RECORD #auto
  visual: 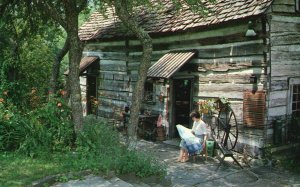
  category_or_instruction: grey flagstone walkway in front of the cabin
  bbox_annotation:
[49,140,300,187]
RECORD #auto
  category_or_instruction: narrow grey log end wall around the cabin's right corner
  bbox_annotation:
[267,0,300,143]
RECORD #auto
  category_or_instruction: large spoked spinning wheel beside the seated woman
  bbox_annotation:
[211,101,238,150]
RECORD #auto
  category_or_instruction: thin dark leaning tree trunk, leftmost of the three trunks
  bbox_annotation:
[49,38,70,93]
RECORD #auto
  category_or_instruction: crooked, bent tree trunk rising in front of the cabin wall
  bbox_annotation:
[114,0,152,149]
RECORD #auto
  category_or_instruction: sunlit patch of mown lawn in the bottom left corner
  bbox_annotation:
[0,153,79,187]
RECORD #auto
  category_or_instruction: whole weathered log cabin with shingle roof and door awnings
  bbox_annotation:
[79,0,300,157]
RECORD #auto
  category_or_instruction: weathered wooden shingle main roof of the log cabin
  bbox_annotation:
[79,0,272,41]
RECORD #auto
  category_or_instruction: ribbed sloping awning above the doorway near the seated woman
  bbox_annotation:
[147,50,197,79]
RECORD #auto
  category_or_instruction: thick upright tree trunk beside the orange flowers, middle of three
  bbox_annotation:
[64,0,83,134]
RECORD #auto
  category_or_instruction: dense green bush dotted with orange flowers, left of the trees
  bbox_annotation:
[0,93,74,156]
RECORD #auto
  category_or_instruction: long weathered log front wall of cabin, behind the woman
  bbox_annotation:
[84,18,268,155]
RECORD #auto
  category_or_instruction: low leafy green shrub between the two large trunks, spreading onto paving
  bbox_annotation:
[76,116,165,177]
